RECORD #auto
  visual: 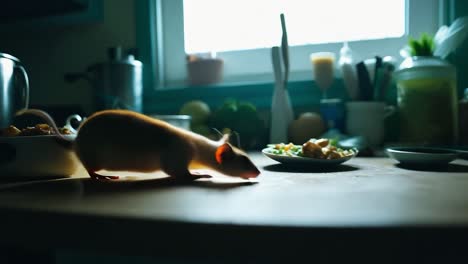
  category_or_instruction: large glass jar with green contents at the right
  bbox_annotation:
[395,57,458,146]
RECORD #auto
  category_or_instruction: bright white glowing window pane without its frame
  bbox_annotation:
[183,0,405,53]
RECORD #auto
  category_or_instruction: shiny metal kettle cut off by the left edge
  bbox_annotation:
[0,53,29,129]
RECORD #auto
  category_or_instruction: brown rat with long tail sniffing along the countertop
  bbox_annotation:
[17,109,260,181]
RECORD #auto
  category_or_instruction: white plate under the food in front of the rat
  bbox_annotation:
[262,148,357,166]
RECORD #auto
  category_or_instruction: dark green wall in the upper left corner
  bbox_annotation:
[0,0,136,112]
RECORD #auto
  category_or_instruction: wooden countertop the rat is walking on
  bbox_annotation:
[0,153,468,256]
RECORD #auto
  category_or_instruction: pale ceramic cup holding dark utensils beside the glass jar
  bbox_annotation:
[346,101,395,148]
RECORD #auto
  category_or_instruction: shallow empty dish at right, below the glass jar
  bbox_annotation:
[387,147,458,165]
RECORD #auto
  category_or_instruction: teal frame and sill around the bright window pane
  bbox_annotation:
[155,0,447,89]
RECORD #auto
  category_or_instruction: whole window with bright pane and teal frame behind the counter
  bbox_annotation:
[157,0,442,86]
